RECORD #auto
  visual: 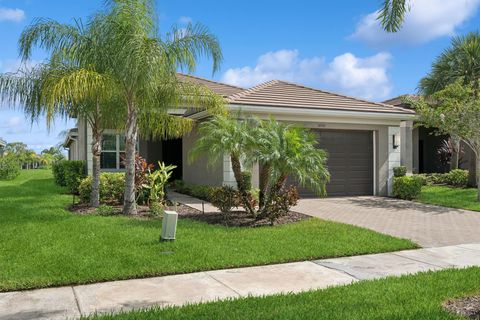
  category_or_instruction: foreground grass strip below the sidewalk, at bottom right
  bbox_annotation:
[88,268,480,320]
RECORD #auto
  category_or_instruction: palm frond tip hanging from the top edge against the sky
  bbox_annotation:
[378,0,410,32]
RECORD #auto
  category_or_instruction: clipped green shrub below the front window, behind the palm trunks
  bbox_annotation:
[79,172,125,205]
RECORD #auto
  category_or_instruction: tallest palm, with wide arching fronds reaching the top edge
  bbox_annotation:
[9,0,223,214]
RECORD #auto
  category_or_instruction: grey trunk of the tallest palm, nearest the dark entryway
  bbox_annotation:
[123,101,138,215]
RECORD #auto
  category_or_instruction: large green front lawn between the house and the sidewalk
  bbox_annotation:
[0,170,416,291]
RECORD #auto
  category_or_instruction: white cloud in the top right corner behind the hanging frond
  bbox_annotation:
[351,0,480,45]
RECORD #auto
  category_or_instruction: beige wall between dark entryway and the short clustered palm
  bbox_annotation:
[182,124,225,186]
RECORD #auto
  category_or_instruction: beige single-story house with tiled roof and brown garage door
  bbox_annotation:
[64,75,415,196]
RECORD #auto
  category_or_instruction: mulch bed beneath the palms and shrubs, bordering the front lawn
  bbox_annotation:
[69,203,310,227]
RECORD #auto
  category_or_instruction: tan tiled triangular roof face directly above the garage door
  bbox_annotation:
[227,80,414,114]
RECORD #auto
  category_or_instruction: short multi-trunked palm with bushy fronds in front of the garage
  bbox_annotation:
[190,115,330,217]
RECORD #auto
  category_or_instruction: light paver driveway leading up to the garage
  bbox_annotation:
[293,197,480,247]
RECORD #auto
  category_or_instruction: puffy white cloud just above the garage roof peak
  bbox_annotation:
[222,50,392,100]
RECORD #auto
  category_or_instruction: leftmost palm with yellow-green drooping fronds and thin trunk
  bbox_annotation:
[0,57,119,207]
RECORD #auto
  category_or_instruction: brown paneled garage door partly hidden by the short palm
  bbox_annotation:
[290,130,373,197]
